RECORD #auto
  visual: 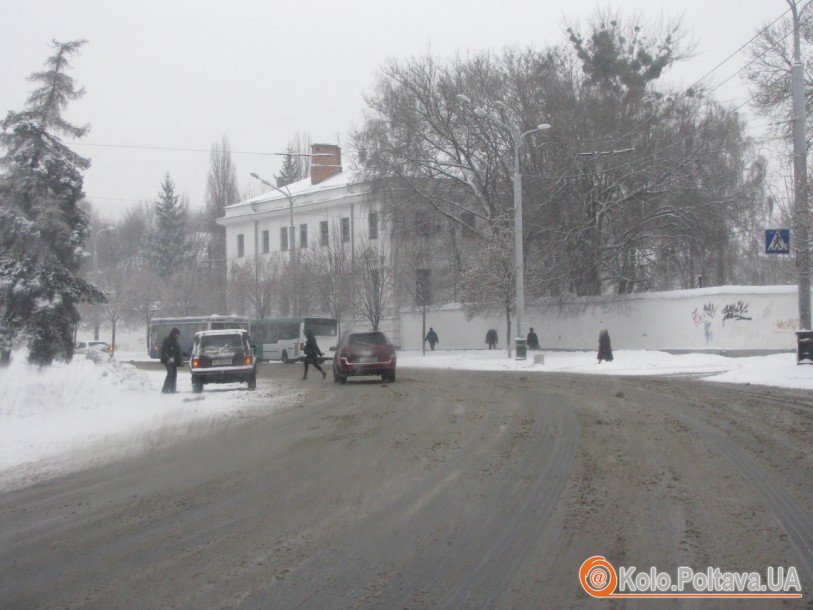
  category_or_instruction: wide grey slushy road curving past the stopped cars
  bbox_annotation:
[0,366,813,608]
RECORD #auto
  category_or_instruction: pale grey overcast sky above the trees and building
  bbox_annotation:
[0,0,788,216]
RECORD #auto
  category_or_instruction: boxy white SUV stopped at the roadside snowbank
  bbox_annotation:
[189,329,257,393]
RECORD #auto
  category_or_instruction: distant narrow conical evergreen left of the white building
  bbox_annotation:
[150,173,188,279]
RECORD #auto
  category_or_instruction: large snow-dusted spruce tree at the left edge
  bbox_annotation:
[0,40,105,365]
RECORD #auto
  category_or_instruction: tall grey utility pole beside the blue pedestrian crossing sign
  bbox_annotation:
[787,0,810,330]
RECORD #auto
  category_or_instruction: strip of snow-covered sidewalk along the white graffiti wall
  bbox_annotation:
[398,349,813,389]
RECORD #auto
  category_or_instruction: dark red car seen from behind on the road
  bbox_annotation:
[333,330,396,383]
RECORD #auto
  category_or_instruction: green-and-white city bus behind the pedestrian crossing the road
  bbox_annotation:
[251,318,339,362]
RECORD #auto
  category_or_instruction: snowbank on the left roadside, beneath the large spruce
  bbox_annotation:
[0,353,274,490]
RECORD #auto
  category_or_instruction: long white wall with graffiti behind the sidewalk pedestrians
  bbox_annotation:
[400,286,799,350]
